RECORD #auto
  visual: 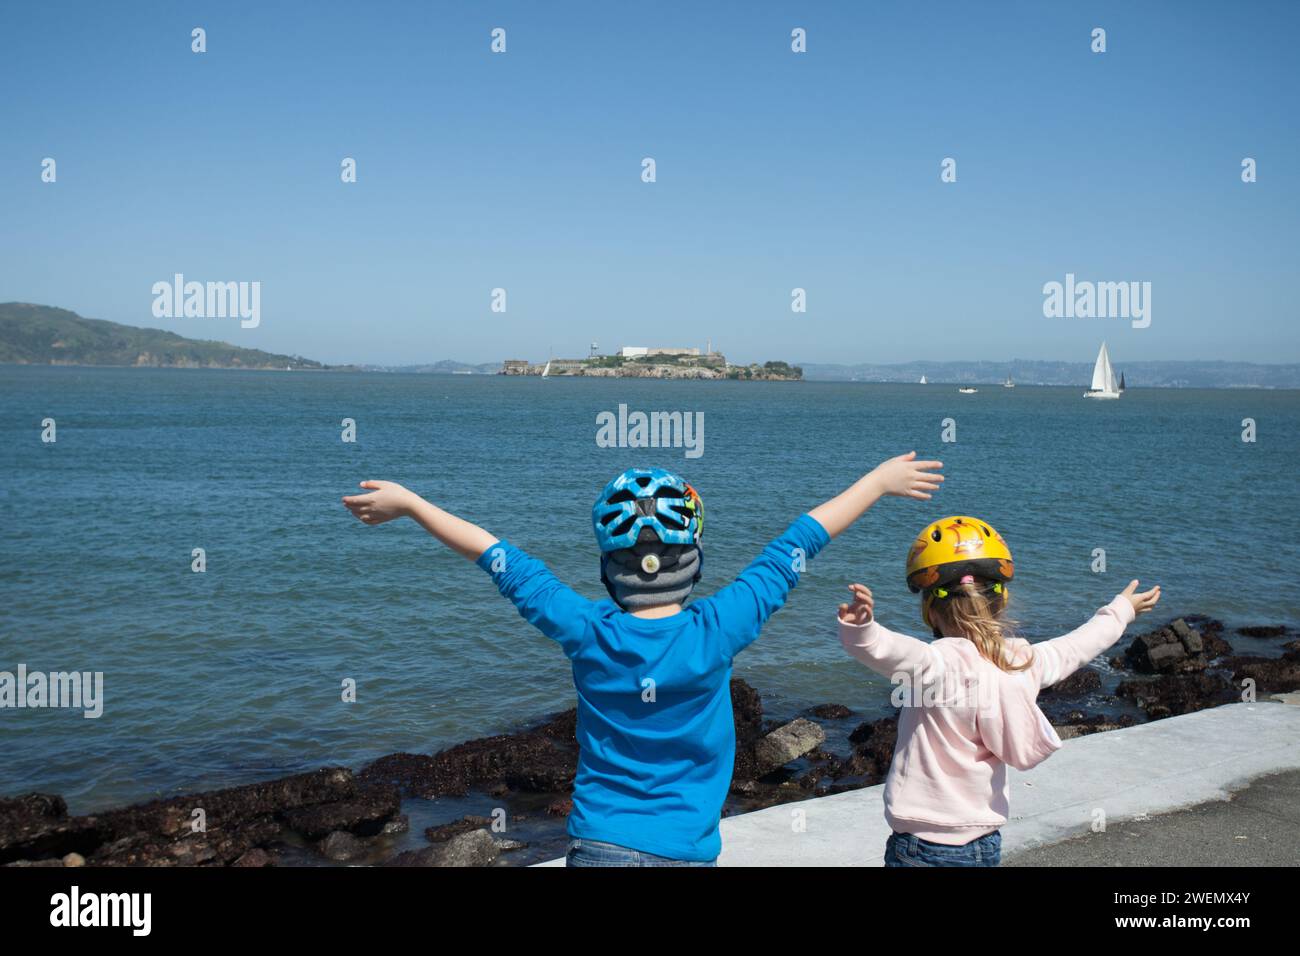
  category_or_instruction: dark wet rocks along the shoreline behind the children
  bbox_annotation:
[0,615,1300,866]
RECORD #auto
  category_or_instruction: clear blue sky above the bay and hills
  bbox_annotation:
[0,0,1300,363]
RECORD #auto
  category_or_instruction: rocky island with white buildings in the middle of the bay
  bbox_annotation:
[501,343,803,381]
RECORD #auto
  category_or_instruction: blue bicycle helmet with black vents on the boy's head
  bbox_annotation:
[592,468,705,554]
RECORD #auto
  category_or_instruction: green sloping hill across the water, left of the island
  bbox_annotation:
[0,302,329,369]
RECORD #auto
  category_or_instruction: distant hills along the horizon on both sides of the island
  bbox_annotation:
[0,302,1300,389]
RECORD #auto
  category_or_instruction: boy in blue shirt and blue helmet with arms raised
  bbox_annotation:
[343,451,944,866]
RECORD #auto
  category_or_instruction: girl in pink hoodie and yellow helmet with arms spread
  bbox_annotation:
[840,515,1160,866]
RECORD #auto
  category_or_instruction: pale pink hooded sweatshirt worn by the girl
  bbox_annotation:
[840,596,1134,845]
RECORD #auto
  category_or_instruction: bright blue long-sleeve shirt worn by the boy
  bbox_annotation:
[478,515,831,860]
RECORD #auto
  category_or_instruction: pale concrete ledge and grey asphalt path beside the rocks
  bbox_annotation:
[542,696,1300,866]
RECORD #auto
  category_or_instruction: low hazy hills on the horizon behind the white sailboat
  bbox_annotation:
[802,355,1300,389]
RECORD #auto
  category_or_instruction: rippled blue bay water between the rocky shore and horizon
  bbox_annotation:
[0,367,1300,812]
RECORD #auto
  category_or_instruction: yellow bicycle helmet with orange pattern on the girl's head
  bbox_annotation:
[907,515,1015,623]
